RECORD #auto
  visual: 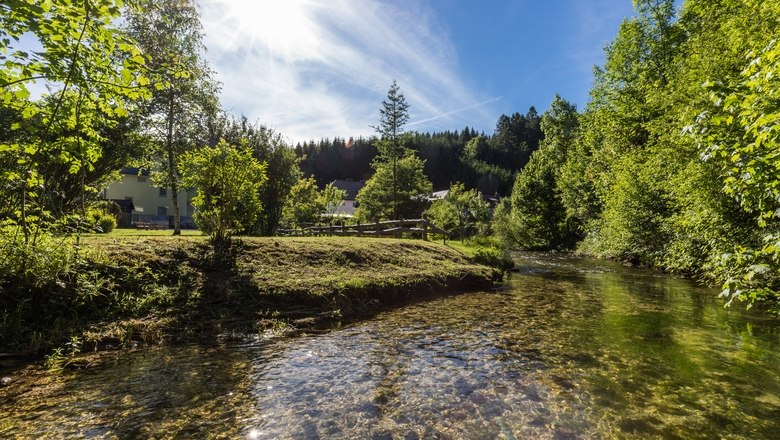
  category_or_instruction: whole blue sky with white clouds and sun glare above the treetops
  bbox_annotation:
[199,0,633,144]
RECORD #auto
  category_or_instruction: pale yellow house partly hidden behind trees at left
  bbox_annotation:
[103,168,195,228]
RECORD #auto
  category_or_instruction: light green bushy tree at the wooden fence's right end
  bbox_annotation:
[426,183,490,240]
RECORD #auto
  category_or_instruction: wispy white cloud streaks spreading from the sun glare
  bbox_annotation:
[201,0,497,142]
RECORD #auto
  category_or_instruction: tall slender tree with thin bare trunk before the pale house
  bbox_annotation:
[128,0,219,235]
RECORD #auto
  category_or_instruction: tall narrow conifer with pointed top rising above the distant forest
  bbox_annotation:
[373,80,409,219]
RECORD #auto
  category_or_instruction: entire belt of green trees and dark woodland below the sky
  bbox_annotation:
[0,0,780,310]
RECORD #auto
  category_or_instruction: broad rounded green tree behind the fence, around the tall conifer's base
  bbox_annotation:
[355,155,432,221]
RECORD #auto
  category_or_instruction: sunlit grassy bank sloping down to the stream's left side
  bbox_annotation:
[2,235,500,360]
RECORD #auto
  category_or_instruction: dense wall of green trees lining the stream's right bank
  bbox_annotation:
[498,0,780,310]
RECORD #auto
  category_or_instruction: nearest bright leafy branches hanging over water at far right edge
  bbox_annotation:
[696,41,780,310]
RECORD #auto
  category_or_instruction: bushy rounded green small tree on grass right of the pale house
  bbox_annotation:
[179,141,266,251]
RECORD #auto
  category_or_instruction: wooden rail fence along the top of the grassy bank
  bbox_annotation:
[279,219,452,242]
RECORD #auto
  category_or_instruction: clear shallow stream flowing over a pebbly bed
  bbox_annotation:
[0,254,780,439]
